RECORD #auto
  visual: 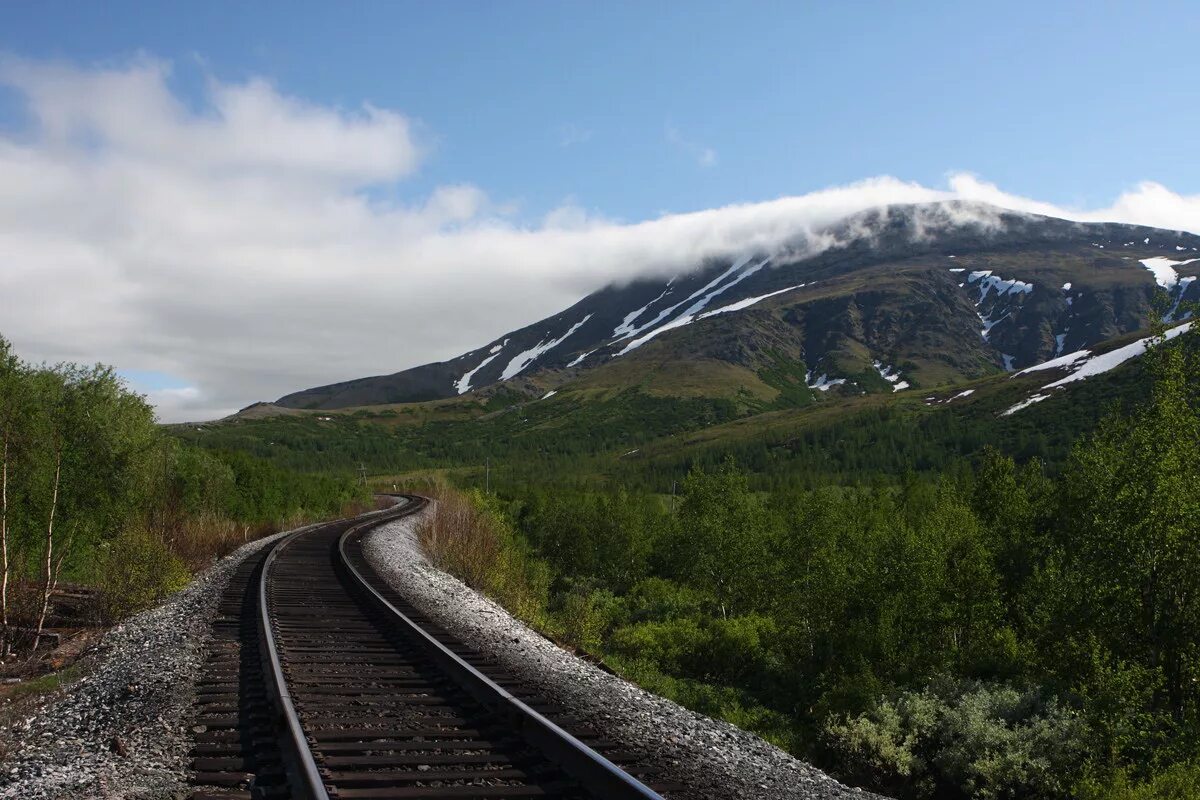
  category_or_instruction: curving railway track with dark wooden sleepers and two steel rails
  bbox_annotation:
[192,498,682,800]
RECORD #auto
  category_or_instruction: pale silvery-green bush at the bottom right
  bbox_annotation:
[824,679,1087,800]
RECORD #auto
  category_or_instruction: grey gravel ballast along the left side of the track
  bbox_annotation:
[0,525,304,799]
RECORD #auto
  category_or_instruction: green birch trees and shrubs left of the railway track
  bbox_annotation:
[0,337,368,666]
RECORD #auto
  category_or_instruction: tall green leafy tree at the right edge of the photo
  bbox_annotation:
[1048,319,1200,753]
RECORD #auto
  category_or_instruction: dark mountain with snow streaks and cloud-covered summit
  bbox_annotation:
[277,201,1200,410]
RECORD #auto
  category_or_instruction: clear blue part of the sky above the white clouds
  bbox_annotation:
[9,2,1200,221]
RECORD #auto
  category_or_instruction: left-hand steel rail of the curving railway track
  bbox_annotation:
[258,499,415,800]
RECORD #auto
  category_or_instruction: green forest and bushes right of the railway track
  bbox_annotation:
[421,321,1200,800]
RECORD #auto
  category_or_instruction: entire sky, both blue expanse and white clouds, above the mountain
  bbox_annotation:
[0,0,1200,421]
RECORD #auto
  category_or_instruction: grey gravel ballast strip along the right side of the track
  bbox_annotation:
[362,511,878,800]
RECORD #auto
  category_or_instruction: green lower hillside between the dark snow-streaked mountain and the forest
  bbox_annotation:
[173,316,1187,492]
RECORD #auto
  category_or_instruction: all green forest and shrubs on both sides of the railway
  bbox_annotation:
[7,316,1200,800]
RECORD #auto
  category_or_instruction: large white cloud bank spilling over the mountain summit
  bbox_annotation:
[0,59,1200,421]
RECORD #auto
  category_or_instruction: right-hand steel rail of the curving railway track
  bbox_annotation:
[337,495,662,800]
